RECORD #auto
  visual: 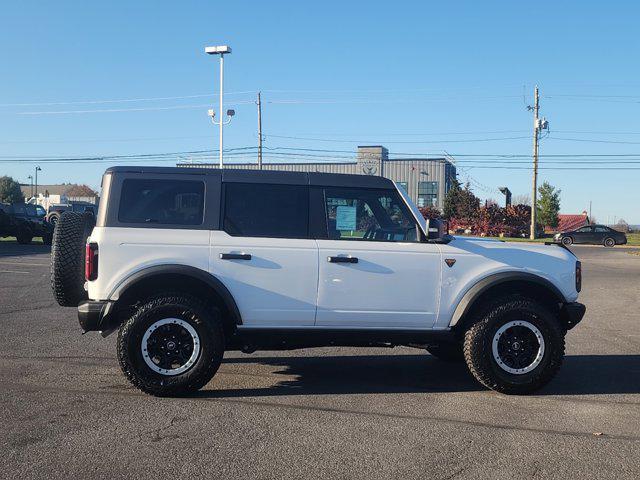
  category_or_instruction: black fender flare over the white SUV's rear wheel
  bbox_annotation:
[109,264,242,330]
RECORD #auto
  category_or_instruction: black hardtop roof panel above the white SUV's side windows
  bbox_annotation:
[105,166,395,189]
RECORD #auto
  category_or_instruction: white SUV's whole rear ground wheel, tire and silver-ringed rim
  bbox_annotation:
[118,294,224,397]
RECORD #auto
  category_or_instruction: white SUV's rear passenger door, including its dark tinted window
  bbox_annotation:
[210,182,318,327]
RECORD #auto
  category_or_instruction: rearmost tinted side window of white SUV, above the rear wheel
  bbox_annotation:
[118,179,204,225]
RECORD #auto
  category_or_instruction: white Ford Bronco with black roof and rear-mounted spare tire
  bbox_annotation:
[51,167,585,396]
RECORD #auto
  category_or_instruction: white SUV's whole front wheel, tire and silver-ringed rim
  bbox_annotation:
[464,296,564,394]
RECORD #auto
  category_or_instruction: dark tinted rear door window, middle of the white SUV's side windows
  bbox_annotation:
[223,183,309,238]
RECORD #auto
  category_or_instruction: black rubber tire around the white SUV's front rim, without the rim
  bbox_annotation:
[464,295,565,395]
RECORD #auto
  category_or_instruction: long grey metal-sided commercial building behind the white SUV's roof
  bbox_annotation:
[178,145,456,210]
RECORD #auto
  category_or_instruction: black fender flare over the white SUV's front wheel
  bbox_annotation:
[449,272,567,330]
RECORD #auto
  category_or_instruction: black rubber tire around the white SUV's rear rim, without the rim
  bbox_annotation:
[117,293,225,397]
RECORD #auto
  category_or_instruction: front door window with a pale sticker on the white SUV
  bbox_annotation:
[325,188,418,242]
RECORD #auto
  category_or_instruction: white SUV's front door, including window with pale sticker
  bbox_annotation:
[316,187,441,329]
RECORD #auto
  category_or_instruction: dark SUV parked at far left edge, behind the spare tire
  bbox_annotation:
[0,203,53,245]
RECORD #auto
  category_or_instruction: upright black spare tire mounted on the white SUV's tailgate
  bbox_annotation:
[51,212,95,307]
